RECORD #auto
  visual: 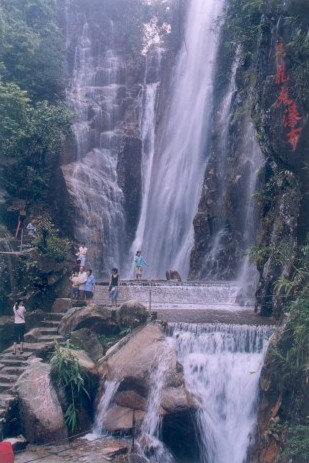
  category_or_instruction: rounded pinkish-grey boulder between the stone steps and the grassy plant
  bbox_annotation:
[16,359,68,444]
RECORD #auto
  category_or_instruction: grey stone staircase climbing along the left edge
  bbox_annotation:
[0,313,64,437]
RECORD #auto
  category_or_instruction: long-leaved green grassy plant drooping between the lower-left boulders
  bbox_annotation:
[50,342,90,432]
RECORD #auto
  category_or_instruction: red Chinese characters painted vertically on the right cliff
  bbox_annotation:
[275,42,302,151]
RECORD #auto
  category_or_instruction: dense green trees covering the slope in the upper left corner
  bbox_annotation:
[0,0,71,201]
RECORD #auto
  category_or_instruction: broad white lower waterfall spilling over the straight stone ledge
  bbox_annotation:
[169,324,273,463]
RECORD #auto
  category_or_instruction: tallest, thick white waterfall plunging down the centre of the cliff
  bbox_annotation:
[132,0,223,278]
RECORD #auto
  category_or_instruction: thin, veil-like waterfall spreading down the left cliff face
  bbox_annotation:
[62,10,126,276]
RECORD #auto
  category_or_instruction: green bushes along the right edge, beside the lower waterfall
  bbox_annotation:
[272,239,309,461]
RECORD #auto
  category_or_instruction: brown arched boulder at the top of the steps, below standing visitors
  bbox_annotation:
[58,306,119,336]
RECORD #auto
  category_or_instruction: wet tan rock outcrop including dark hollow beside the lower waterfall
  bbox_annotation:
[95,324,198,461]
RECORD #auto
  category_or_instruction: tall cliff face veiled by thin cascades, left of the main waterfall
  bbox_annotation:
[58,0,178,277]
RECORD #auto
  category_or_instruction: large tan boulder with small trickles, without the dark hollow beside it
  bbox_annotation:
[98,324,198,433]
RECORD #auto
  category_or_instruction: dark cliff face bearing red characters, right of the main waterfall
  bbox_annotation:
[191,0,309,308]
